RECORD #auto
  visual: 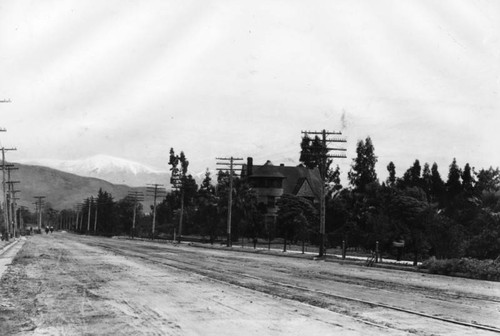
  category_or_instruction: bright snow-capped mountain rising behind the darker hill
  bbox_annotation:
[18,155,170,187]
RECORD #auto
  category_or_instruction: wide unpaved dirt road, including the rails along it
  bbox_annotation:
[0,233,500,335]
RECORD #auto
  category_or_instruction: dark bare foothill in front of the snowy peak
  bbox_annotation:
[11,163,153,210]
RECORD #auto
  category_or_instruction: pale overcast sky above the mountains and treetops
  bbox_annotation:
[0,0,500,181]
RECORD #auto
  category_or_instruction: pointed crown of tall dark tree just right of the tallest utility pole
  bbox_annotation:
[348,137,378,192]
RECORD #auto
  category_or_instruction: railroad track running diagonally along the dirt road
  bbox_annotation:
[86,241,500,334]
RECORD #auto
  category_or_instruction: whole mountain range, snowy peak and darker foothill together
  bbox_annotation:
[11,155,217,210]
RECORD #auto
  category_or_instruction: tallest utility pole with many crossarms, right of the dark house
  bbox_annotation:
[302,130,347,257]
